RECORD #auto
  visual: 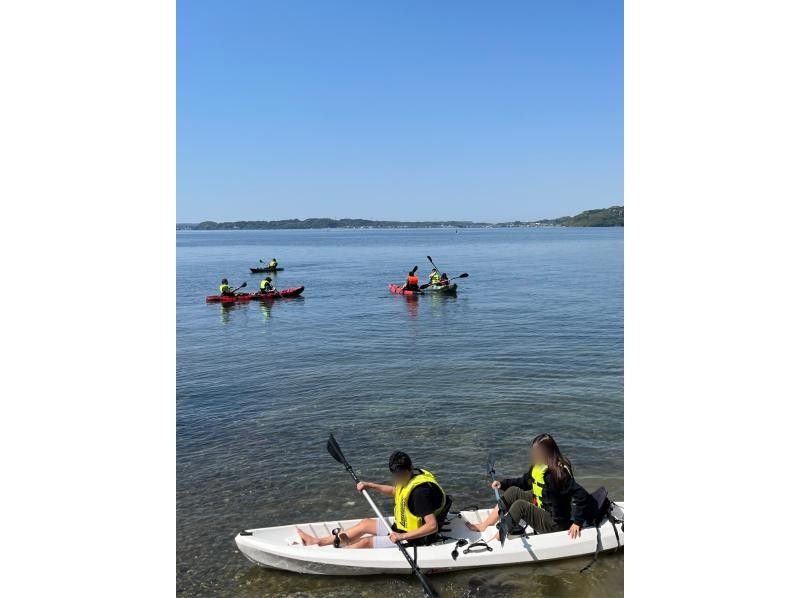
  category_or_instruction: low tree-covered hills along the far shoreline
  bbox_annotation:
[177,206,625,230]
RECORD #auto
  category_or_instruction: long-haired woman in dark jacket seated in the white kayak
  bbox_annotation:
[467,434,590,539]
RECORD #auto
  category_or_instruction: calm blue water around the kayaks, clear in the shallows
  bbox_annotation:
[176,228,624,598]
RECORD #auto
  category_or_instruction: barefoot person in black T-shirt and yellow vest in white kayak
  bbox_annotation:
[297,451,451,548]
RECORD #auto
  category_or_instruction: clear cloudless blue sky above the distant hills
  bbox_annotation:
[178,0,623,222]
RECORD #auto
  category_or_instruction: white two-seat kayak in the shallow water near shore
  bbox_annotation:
[236,503,625,575]
